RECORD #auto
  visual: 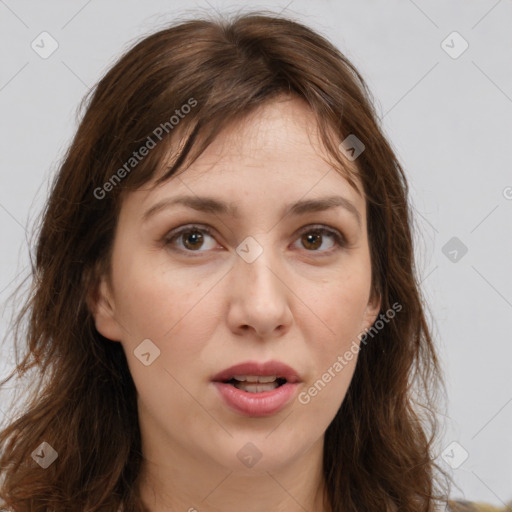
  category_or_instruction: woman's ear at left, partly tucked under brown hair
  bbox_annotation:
[87,275,122,341]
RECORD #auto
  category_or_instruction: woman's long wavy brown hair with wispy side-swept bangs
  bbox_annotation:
[0,12,444,512]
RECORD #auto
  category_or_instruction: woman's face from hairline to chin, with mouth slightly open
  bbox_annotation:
[94,99,380,480]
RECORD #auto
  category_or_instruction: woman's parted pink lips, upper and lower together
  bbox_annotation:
[212,361,301,416]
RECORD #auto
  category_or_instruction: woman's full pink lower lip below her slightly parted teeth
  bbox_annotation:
[214,382,299,417]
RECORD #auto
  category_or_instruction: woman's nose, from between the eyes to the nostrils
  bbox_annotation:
[228,240,293,339]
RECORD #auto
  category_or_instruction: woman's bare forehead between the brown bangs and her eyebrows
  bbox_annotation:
[125,97,364,219]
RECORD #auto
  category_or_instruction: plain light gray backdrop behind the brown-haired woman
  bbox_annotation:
[0,0,512,505]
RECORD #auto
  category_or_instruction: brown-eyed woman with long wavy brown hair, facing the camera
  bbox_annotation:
[0,8,504,512]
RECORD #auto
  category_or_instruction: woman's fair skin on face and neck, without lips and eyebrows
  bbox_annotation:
[93,98,380,512]
